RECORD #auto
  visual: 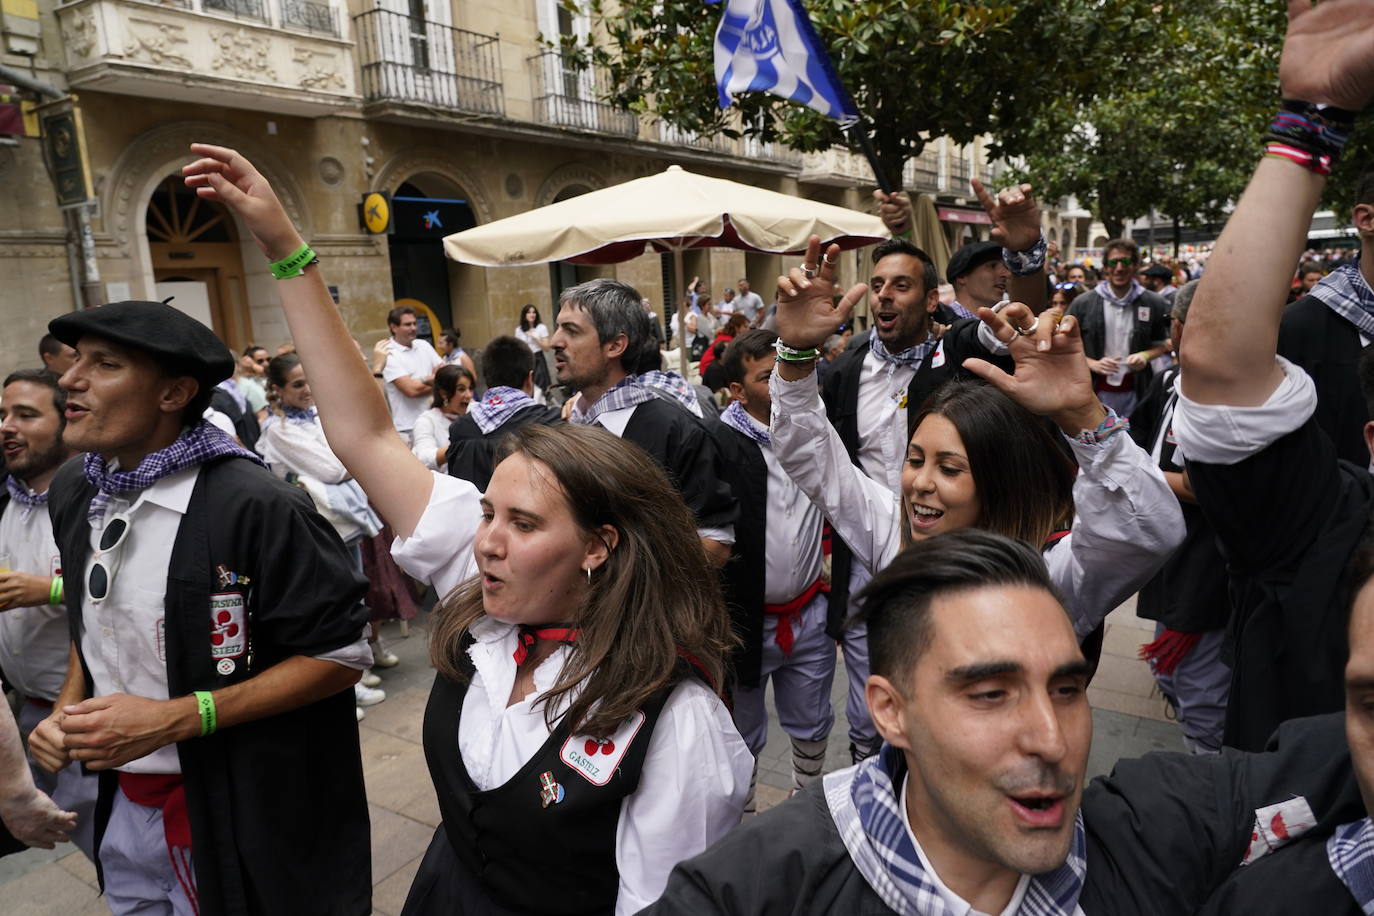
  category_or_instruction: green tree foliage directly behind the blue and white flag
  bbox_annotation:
[563,0,1151,190]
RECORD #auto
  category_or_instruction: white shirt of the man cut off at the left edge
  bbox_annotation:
[0,500,71,700]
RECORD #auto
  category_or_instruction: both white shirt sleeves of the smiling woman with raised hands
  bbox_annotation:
[768,369,1183,639]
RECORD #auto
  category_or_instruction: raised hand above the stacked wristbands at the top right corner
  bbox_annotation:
[1279,0,1374,111]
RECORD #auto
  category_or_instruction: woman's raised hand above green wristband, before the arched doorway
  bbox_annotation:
[181,143,301,261]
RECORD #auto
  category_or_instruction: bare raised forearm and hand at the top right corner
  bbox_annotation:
[1179,0,1374,407]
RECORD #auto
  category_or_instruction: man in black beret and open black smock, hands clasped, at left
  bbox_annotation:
[30,302,371,916]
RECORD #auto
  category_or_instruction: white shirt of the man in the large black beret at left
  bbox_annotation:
[80,464,372,773]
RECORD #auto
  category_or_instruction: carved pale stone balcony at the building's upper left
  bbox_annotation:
[56,0,357,117]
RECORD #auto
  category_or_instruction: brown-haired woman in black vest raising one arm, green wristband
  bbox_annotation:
[184,144,753,916]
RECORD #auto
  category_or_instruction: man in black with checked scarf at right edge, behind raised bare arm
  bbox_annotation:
[1269,172,1374,464]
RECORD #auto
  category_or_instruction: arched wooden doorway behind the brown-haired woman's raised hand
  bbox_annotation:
[146,174,253,353]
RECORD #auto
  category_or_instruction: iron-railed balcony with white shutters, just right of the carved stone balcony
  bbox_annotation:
[353,10,506,115]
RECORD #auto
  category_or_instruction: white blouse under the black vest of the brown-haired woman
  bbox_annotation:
[392,474,754,916]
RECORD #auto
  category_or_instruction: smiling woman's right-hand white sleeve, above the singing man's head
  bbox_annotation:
[1044,433,1184,639]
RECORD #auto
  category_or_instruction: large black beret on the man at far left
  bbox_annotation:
[48,299,234,386]
